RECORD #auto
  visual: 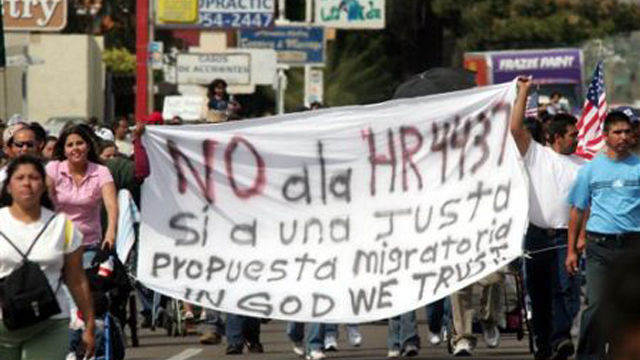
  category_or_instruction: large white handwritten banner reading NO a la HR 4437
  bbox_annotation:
[137,83,528,323]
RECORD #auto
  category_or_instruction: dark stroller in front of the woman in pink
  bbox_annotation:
[67,251,133,360]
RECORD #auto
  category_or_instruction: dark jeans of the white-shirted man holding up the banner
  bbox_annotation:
[525,225,580,355]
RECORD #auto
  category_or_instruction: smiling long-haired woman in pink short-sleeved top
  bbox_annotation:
[47,125,118,253]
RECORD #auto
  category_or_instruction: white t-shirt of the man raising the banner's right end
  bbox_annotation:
[524,140,585,229]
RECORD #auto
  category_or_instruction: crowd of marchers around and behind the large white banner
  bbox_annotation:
[0,78,640,360]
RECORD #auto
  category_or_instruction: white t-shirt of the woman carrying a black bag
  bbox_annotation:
[0,207,82,319]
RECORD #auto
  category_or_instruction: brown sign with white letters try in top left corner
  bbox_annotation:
[2,0,68,31]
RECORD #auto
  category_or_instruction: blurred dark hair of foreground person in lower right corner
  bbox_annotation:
[596,249,640,352]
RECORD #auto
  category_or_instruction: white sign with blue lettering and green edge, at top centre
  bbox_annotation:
[315,0,385,29]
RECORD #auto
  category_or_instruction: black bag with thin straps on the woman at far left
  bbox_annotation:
[0,215,60,330]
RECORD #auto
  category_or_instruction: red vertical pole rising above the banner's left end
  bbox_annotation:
[135,0,149,121]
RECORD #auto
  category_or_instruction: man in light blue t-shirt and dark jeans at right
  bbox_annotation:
[566,111,640,360]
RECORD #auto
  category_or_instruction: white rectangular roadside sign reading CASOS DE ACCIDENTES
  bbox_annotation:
[177,53,251,85]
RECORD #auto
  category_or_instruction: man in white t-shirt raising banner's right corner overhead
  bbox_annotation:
[511,78,584,360]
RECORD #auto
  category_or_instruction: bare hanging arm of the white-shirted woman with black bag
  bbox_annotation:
[63,247,95,357]
